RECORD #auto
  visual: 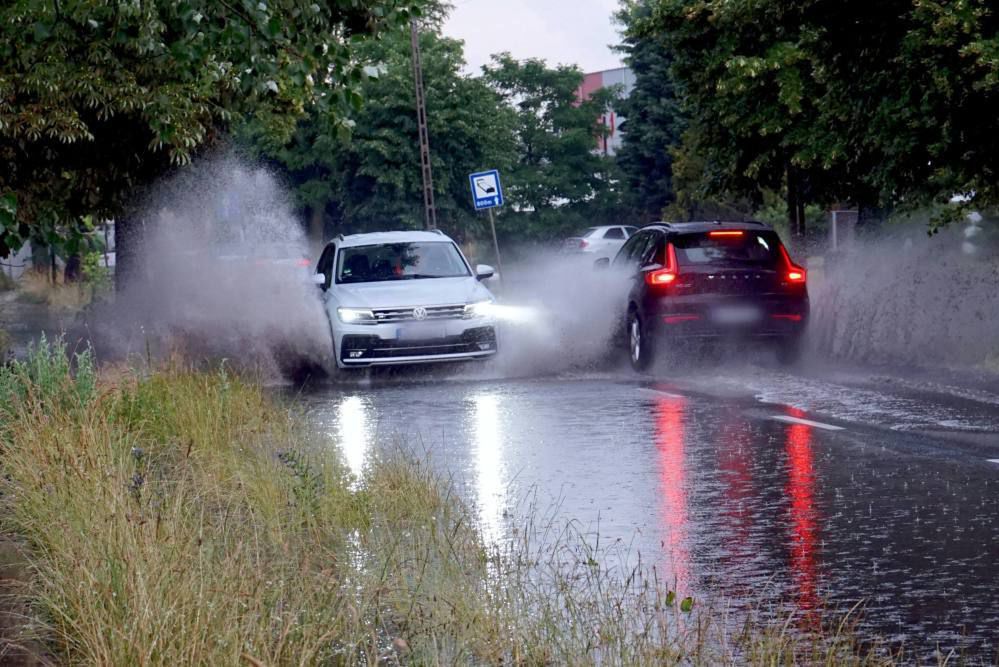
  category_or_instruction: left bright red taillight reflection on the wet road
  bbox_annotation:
[656,396,690,595]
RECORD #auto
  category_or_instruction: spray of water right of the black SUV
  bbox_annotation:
[811,227,999,367]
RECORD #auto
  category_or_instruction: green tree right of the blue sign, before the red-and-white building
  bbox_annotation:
[483,54,619,239]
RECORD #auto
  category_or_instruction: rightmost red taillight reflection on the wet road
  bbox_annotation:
[784,409,819,612]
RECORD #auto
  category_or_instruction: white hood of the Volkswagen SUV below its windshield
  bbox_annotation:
[335,277,492,308]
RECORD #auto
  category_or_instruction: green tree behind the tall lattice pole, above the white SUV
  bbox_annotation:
[249,30,515,243]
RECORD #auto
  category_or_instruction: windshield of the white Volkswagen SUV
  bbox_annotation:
[336,241,471,283]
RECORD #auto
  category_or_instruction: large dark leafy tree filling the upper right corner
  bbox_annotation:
[631,0,999,233]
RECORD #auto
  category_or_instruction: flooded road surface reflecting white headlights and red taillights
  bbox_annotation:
[302,363,999,661]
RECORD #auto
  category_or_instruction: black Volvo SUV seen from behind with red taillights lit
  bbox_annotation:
[603,222,809,370]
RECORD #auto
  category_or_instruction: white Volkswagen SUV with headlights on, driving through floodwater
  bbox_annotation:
[315,232,497,368]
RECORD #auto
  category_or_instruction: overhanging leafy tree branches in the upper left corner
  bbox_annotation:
[0,0,421,268]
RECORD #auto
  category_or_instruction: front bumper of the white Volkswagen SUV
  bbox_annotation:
[336,320,498,368]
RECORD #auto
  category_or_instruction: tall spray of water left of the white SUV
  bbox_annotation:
[82,155,330,378]
